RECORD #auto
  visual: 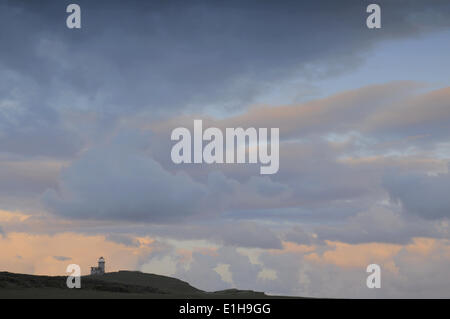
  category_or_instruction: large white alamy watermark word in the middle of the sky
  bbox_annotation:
[171,120,279,174]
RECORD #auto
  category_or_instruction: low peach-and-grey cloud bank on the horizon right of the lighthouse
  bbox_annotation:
[166,238,450,298]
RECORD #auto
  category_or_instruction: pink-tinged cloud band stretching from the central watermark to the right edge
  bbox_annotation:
[155,81,450,147]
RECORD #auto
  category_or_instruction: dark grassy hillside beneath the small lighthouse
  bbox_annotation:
[0,271,292,299]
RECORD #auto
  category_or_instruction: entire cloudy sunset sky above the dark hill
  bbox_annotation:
[0,0,450,298]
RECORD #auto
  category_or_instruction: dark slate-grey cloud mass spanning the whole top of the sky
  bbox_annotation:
[0,0,449,119]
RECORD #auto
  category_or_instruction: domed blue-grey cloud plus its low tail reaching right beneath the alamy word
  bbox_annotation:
[43,131,296,225]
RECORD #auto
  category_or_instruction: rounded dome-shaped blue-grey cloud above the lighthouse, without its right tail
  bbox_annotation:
[44,139,207,222]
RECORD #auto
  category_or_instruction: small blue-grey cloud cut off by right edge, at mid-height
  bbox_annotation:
[383,165,450,219]
